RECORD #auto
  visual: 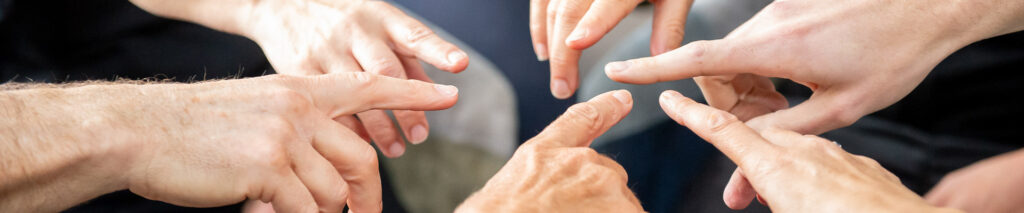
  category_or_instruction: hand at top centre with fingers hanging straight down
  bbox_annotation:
[529,0,693,99]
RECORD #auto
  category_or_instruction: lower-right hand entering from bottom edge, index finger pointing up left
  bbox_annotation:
[660,91,954,212]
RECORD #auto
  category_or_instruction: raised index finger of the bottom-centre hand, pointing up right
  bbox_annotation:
[526,90,633,147]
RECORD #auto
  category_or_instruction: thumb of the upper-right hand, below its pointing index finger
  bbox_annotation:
[746,89,865,135]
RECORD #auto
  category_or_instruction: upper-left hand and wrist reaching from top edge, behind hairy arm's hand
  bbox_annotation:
[132,0,469,158]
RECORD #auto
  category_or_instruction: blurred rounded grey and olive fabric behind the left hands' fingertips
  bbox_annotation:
[378,5,518,212]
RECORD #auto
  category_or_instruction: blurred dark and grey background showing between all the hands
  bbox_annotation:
[0,0,1024,212]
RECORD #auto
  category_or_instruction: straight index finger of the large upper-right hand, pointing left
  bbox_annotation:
[604,40,768,84]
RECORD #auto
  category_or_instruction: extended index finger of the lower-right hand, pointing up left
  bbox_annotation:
[659,90,775,165]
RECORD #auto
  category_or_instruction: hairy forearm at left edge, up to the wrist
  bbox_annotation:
[0,85,142,212]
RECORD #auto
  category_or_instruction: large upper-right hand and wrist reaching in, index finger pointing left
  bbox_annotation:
[605,0,1024,209]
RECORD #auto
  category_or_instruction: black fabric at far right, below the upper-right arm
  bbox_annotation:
[779,32,1024,194]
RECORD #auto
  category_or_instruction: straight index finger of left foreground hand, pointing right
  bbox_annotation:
[303,72,459,118]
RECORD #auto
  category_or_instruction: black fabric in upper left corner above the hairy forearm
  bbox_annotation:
[0,0,272,82]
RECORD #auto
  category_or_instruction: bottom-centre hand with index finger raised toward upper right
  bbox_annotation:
[456,90,643,213]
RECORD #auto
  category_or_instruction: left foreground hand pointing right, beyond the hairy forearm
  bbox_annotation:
[120,73,458,212]
